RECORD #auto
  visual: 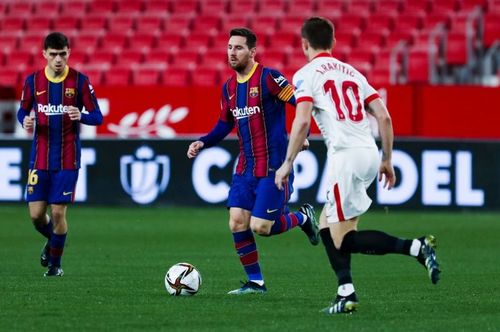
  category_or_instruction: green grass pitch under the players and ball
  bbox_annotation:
[0,205,500,332]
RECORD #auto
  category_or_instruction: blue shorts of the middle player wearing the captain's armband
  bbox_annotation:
[227,172,293,220]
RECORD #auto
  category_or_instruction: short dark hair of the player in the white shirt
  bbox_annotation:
[301,16,335,50]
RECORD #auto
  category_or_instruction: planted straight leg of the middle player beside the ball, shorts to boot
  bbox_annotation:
[227,175,266,295]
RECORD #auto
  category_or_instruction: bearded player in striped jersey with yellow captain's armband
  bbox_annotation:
[187,28,319,295]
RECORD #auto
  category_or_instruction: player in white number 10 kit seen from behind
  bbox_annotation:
[275,17,440,314]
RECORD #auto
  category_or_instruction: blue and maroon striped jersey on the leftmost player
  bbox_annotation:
[17,67,102,170]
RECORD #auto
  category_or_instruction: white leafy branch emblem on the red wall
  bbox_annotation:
[108,104,189,138]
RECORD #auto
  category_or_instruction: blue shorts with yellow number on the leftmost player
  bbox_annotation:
[26,169,78,204]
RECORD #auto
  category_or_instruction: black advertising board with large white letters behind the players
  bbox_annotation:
[0,139,500,210]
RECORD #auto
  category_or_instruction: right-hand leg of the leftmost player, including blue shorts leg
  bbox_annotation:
[44,170,78,276]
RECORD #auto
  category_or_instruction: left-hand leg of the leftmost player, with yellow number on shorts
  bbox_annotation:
[26,169,52,267]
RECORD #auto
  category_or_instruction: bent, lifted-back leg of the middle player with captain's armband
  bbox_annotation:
[250,176,319,245]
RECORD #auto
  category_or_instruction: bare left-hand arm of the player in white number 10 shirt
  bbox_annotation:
[274,100,313,190]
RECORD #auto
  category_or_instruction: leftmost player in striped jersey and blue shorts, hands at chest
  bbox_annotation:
[17,32,102,277]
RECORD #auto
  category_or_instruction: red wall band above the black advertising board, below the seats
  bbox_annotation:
[0,85,500,139]
